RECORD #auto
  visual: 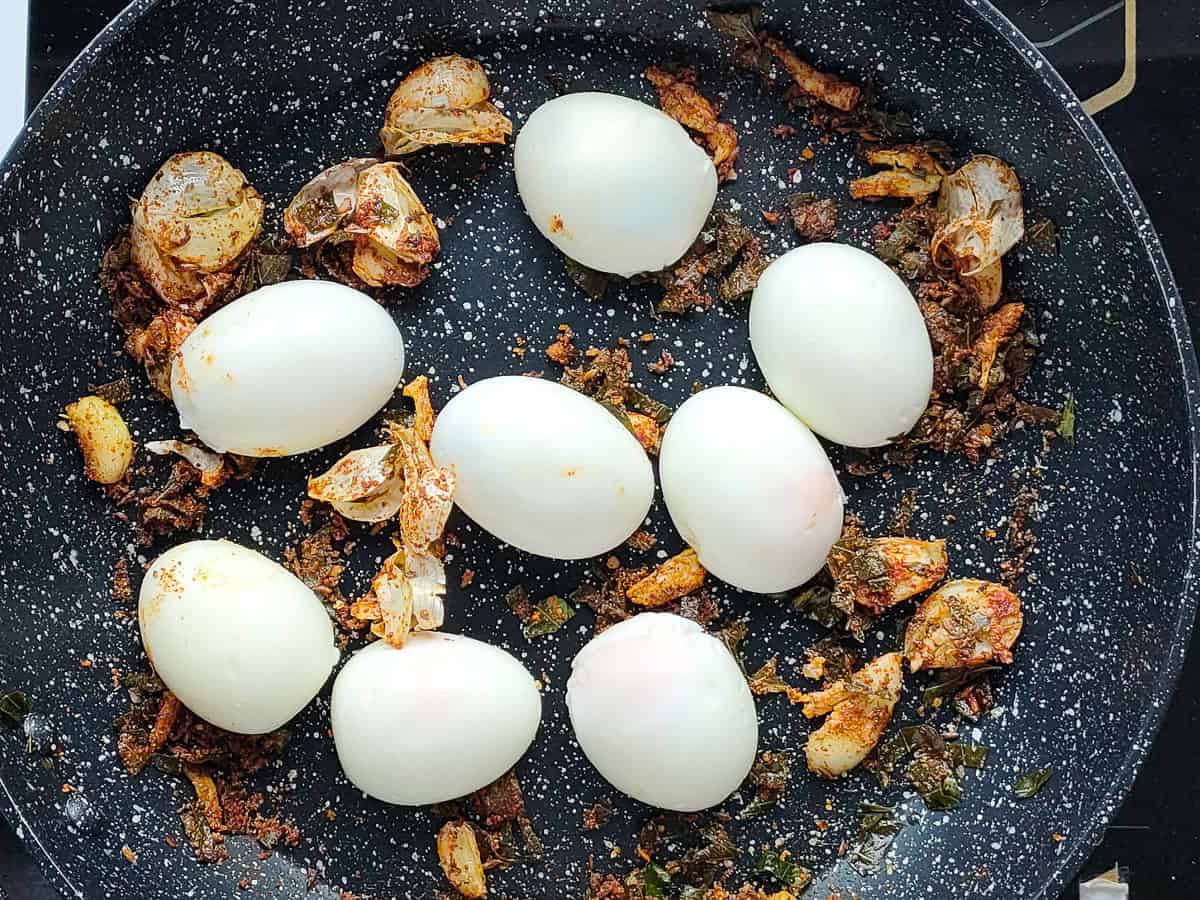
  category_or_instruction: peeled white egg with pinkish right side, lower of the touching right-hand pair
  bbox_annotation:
[659,388,842,594]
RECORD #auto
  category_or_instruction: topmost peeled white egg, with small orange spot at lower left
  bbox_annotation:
[512,92,716,276]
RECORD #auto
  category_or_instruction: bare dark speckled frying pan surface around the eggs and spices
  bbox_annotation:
[0,0,1198,900]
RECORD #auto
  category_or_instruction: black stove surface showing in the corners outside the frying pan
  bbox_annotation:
[0,0,1200,900]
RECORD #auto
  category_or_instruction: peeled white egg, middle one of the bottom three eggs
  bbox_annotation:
[331,632,541,806]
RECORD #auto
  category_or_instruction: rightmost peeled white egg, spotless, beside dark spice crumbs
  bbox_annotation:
[750,244,934,446]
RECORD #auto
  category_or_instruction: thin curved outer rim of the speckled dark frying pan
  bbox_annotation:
[0,0,1200,900]
